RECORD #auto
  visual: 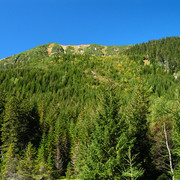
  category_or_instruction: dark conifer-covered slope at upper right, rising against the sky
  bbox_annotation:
[125,37,180,73]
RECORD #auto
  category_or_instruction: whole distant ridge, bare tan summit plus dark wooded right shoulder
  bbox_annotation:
[0,36,180,77]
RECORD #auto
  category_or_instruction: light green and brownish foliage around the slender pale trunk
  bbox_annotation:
[150,97,178,177]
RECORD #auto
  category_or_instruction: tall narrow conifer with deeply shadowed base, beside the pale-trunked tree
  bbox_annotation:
[127,84,153,179]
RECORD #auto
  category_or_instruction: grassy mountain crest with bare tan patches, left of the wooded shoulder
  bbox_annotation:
[0,43,131,63]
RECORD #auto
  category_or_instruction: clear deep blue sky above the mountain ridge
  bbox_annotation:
[0,0,180,59]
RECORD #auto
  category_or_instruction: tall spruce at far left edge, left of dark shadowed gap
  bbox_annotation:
[1,96,24,178]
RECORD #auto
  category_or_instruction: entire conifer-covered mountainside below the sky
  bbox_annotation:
[0,37,180,180]
